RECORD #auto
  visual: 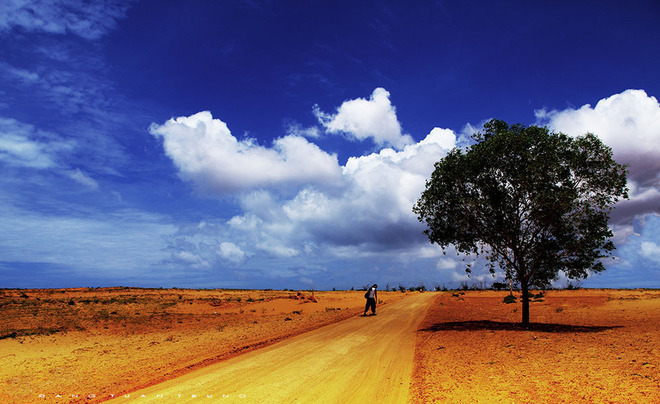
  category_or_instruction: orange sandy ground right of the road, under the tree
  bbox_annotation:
[411,290,660,403]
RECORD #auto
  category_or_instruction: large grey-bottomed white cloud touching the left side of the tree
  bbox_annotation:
[219,126,455,258]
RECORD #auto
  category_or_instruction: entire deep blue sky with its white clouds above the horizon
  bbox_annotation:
[0,0,660,289]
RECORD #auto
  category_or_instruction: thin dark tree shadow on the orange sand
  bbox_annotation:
[420,320,622,333]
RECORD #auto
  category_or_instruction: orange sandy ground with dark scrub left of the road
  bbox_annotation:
[0,288,405,403]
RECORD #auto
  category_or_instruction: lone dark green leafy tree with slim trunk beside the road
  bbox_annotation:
[413,120,628,325]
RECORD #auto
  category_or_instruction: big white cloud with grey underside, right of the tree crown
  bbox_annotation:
[536,90,660,224]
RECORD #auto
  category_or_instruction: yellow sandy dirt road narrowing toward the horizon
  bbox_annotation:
[111,293,436,404]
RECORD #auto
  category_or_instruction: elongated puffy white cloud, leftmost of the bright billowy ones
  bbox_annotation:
[150,112,341,195]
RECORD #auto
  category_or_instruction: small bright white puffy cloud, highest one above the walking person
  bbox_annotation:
[314,87,413,149]
